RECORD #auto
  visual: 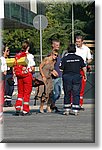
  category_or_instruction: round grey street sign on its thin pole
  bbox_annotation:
[33,15,48,61]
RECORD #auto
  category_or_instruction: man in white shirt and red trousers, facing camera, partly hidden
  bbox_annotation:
[76,36,92,107]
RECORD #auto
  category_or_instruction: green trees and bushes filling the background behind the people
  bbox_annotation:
[3,2,95,63]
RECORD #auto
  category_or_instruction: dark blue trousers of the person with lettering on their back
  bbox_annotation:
[62,73,81,105]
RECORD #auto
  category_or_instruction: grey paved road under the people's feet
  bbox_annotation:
[2,99,95,143]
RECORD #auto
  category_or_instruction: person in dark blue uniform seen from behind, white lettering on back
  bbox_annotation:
[60,44,86,115]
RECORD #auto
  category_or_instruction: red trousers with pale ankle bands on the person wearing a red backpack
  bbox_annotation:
[15,73,32,113]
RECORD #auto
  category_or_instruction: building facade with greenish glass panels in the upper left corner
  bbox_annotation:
[3,0,44,29]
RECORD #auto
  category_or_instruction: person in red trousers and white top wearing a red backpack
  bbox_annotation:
[14,41,35,116]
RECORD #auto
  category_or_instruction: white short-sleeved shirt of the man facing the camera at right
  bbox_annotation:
[75,44,92,63]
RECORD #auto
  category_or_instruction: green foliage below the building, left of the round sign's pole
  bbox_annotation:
[3,29,39,53]
